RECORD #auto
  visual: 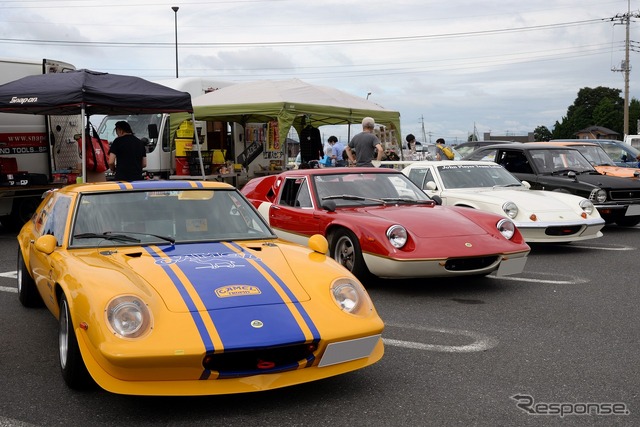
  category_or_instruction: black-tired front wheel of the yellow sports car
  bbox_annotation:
[58,294,95,390]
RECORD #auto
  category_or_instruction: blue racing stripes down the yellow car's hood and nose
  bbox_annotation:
[150,243,310,350]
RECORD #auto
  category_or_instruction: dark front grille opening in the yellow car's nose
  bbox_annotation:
[202,343,318,376]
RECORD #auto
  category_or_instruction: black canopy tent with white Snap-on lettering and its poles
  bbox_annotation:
[0,69,199,180]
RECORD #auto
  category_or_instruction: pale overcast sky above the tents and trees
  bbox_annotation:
[0,0,640,142]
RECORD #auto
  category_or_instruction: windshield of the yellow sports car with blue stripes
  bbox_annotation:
[70,189,275,247]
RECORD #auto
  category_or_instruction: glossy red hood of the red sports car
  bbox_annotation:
[358,205,487,238]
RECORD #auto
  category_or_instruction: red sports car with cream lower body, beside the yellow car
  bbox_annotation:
[241,168,530,280]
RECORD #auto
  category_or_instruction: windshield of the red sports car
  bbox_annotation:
[313,173,431,206]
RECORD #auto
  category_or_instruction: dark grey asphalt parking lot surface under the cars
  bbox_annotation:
[0,227,640,426]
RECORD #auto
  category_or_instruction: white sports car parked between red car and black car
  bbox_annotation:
[402,160,605,243]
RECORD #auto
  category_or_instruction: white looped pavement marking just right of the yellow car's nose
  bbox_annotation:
[382,322,499,353]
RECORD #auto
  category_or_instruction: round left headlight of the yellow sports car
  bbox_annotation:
[105,295,151,338]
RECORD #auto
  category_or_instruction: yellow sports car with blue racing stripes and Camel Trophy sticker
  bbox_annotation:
[18,181,384,395]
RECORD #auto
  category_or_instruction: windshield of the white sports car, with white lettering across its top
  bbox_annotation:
[438,164,522,189]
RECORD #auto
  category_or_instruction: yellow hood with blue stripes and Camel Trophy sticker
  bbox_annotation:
[81,241,309,312]
